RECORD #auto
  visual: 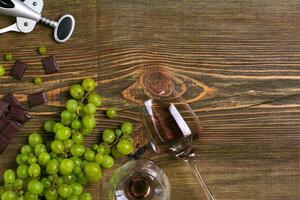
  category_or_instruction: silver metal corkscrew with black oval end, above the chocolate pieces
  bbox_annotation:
[0,0,75,43]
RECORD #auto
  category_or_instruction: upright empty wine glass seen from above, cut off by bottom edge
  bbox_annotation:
[109,159,171,200]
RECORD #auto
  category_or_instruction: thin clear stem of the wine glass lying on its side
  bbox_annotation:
[185,156,217,200]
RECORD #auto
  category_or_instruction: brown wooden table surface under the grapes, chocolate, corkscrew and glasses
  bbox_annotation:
[0,0,300,200]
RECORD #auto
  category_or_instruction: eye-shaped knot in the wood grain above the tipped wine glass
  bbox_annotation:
[122,66,215,105]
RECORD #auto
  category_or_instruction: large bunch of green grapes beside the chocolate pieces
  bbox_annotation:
[0,79,133,200]
